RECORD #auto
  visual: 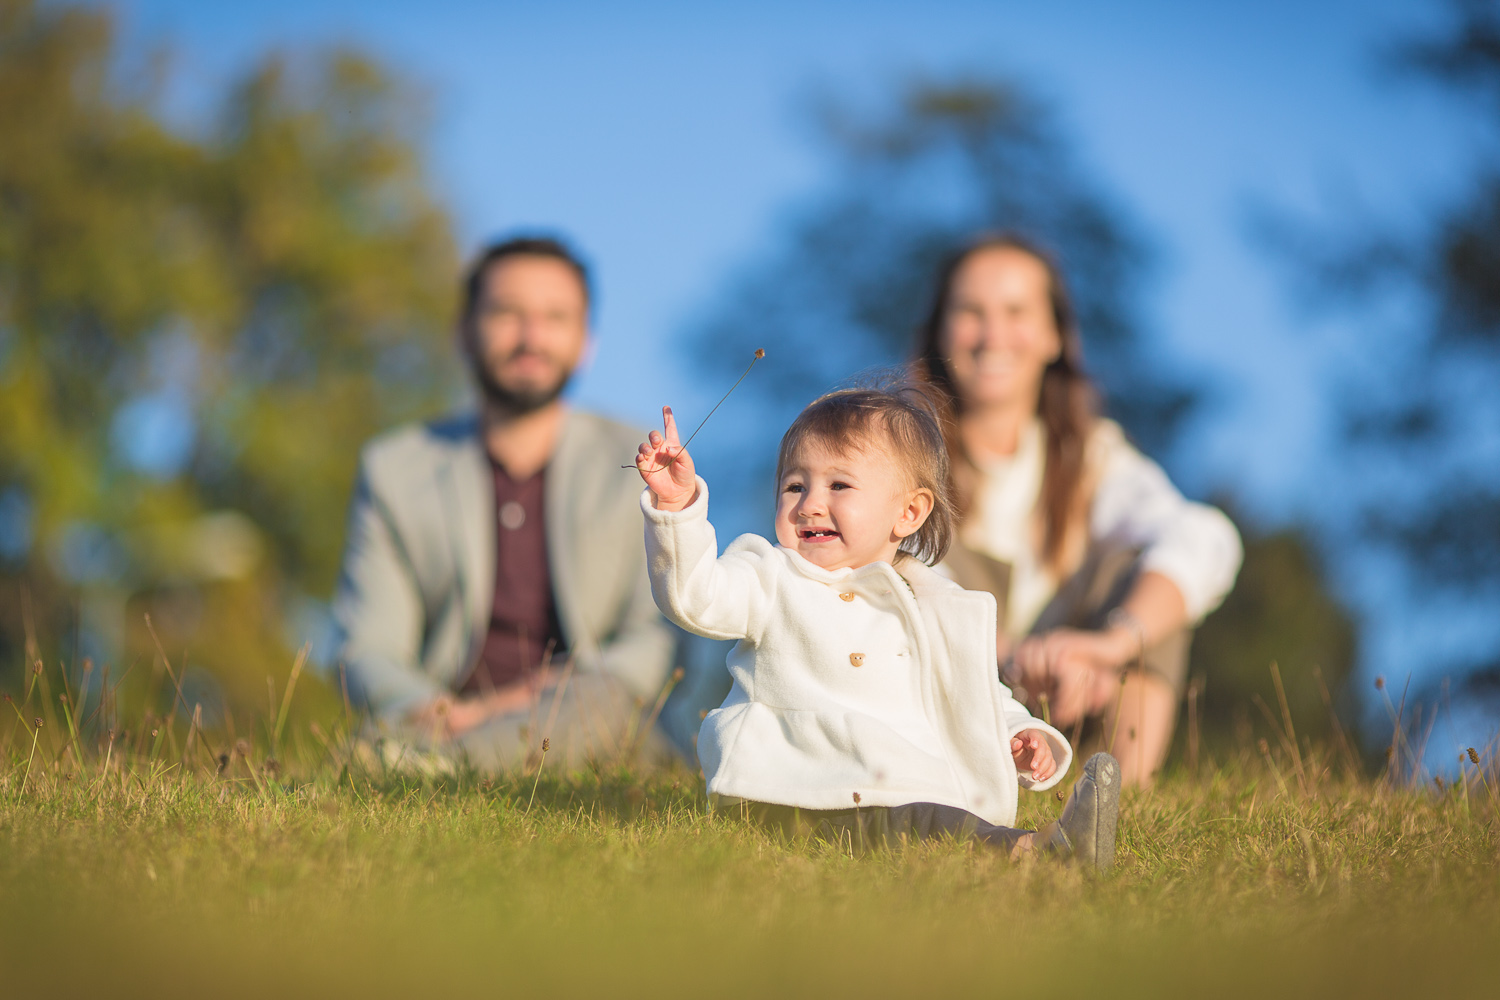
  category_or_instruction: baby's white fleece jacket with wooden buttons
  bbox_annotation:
[641,478,1073,826]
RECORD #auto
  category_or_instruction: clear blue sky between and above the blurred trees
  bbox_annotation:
[114,0,1479,719]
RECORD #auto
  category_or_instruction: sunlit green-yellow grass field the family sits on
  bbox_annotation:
[0,659,1500,1000]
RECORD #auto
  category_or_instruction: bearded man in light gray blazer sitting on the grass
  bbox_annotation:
[335,238,677,768]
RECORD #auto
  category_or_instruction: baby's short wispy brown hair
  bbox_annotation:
[776,379,956,565]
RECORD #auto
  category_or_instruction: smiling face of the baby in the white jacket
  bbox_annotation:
[776,439,932,570]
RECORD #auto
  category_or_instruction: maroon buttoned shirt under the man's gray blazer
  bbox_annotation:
[462,460,563,694]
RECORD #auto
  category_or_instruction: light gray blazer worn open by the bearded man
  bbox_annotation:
[333,411,677,720]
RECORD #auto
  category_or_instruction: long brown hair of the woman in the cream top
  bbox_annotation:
[915,234,1098,573]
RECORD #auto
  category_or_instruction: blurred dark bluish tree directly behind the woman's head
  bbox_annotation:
[693,78,1194,464]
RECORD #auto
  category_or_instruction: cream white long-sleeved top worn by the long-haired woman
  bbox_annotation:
[963,420,1244,636]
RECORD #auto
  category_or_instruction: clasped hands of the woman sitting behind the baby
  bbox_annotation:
[1016,628,1136,726]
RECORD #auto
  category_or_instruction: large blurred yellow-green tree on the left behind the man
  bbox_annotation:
[0,0,455,710]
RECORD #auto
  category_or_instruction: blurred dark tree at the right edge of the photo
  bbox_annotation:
[1268,0,1500,708]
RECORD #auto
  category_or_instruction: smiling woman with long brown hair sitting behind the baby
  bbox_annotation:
[917,237,1242,784]
